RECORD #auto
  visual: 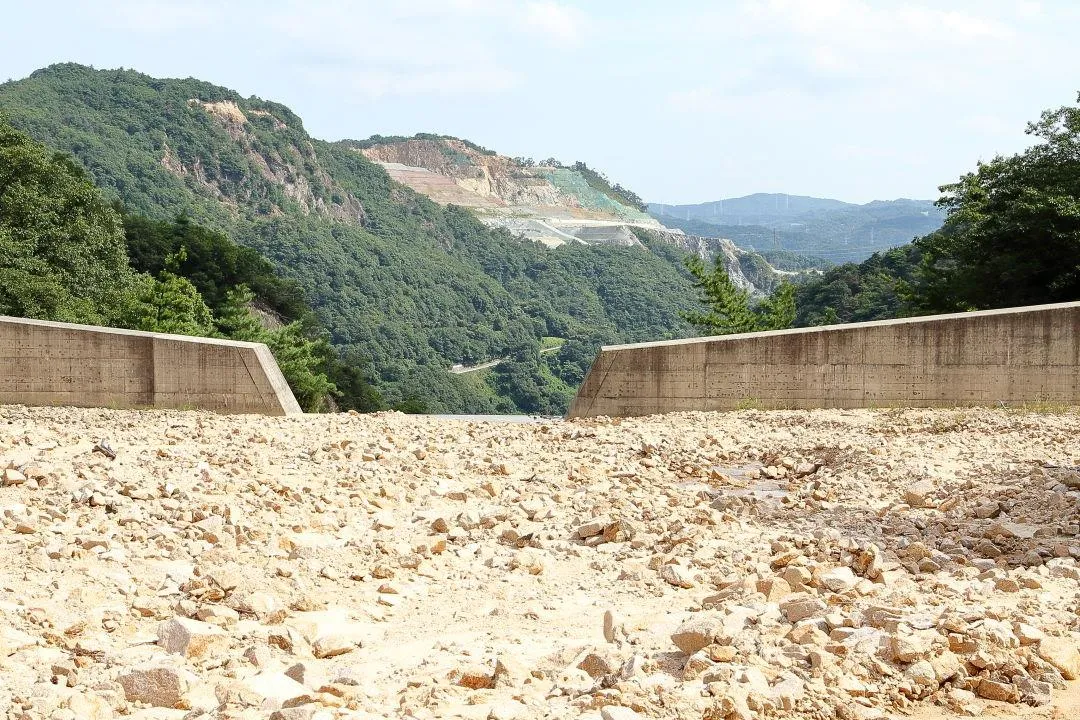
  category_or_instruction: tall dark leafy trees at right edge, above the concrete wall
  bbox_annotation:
[910,93,1080,312]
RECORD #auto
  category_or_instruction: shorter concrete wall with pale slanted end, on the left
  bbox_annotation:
[0,316,300,415]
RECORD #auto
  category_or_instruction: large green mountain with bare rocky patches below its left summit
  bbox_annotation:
[0,64,725,412]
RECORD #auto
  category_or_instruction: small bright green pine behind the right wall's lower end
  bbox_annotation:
[680,255,795,335]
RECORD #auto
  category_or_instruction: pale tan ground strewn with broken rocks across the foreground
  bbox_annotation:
[0,407,1080,720]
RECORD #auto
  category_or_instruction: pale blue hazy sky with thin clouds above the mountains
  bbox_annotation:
[0,0,1080,203]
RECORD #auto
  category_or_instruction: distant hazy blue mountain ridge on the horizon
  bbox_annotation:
[649,193,945,262]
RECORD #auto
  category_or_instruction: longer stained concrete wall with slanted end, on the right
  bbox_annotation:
[568,302,1080,417]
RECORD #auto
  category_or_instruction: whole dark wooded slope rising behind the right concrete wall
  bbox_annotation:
[796,90,1080,325]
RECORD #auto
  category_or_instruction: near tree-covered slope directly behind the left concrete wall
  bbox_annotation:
[0,117,345,410]
